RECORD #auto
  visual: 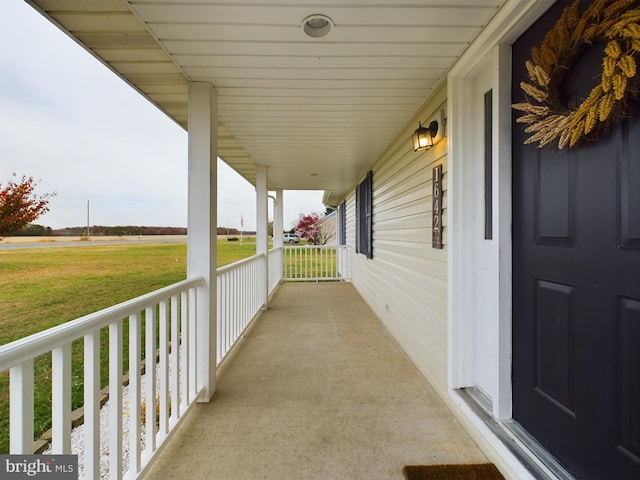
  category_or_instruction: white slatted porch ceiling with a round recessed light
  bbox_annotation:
[27,0,506,204]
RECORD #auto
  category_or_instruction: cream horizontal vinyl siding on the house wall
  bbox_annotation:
[347,86,447,395]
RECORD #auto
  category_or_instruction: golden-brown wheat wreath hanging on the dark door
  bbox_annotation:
[513,0,640,149]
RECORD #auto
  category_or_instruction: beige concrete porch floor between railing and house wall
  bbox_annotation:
[145,283,487,480]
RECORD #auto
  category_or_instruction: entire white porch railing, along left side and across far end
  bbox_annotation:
[0,246,349,479]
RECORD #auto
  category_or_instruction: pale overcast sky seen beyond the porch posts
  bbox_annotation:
[0,0,324,230]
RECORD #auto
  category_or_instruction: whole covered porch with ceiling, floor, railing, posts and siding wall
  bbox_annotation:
[0,0,560,479]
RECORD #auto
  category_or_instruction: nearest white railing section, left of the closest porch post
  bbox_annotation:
[0,278,204,479]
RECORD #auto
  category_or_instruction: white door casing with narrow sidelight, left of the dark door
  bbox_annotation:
[447,0,553,420]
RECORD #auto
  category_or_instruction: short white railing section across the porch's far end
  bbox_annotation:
[282,245,351,282]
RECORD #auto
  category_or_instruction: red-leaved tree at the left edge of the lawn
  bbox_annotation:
[0,173,56,235]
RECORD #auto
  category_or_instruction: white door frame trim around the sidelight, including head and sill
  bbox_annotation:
[447,0,555,471]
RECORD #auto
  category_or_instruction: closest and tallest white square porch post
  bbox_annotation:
[187,82,218,402]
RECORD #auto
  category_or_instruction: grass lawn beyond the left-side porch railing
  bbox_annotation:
[0,240,255,454]
